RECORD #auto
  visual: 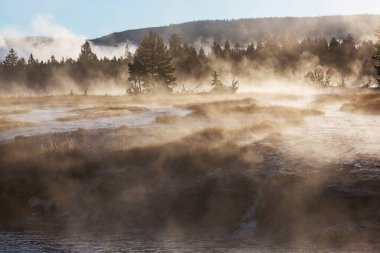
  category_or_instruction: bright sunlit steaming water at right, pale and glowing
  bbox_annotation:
[278,97,380,163]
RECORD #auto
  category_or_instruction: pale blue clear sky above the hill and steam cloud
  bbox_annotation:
[0,0,380,38]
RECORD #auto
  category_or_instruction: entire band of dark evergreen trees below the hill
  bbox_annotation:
[0,31,379,94]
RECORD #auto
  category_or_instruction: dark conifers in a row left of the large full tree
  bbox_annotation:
[0,41,131,92]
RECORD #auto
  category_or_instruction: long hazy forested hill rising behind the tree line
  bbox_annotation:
[92,15,380,46]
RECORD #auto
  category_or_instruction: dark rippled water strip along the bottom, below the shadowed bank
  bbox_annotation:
[0,231,374,253]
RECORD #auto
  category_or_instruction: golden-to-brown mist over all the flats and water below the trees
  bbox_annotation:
[0,89,380,252]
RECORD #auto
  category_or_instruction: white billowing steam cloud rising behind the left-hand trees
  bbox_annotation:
[0,15,131,61]
